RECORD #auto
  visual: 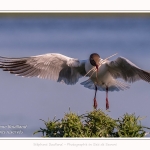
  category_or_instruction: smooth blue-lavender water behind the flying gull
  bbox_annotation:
[0,16,150,137]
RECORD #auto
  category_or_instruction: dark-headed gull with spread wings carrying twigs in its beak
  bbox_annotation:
[0,53,150,109]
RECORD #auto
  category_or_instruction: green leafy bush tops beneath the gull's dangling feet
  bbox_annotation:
[34,109,150,137]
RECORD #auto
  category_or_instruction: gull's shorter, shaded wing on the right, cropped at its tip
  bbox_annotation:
[107,57,150,83]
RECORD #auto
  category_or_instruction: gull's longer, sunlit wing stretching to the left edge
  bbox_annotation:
[0,53,86,84]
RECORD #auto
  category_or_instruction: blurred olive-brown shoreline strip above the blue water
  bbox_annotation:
[0,11,150,17]
